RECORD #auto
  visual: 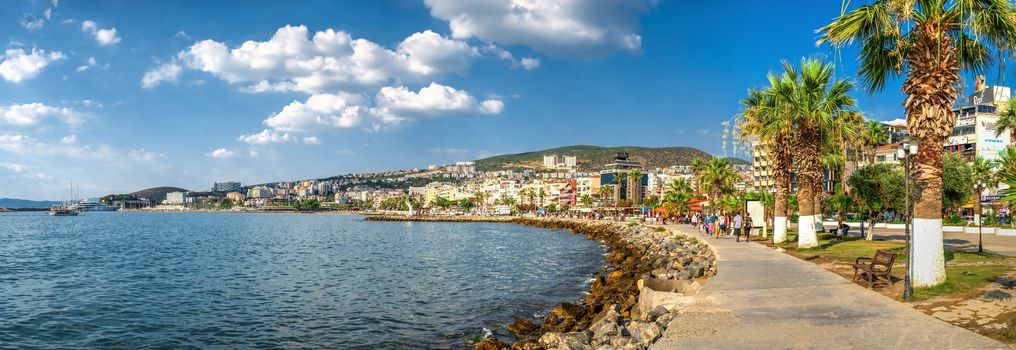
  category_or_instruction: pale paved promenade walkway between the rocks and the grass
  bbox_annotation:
[652,225,1009,349]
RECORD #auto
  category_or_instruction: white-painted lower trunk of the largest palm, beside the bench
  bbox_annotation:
[910,218,946,287]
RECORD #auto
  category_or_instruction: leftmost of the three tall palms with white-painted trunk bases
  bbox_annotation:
[741,84,793,242]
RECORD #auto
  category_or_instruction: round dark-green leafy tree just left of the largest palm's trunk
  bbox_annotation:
[849,164,904,240]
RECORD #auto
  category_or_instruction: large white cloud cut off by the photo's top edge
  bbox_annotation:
[424,0,656,57]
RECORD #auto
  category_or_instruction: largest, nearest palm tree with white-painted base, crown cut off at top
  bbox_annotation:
[818,0,1016,287]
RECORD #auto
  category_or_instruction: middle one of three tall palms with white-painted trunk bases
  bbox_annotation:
[773,59,856,248]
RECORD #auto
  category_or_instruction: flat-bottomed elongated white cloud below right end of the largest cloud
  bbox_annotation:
[372,82,504,123]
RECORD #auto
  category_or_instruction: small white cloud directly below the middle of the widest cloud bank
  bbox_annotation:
[262,93,368,132]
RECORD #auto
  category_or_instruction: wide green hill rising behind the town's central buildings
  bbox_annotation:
[475,145,748,171]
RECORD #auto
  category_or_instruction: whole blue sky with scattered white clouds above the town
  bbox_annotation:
[0,0,995,199]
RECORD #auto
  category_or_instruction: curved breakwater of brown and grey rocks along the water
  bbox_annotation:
[368,216,716,350]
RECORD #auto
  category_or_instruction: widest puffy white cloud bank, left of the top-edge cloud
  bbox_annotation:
[178,25,478,94]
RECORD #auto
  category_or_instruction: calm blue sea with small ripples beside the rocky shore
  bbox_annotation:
[0,213,604,349]
